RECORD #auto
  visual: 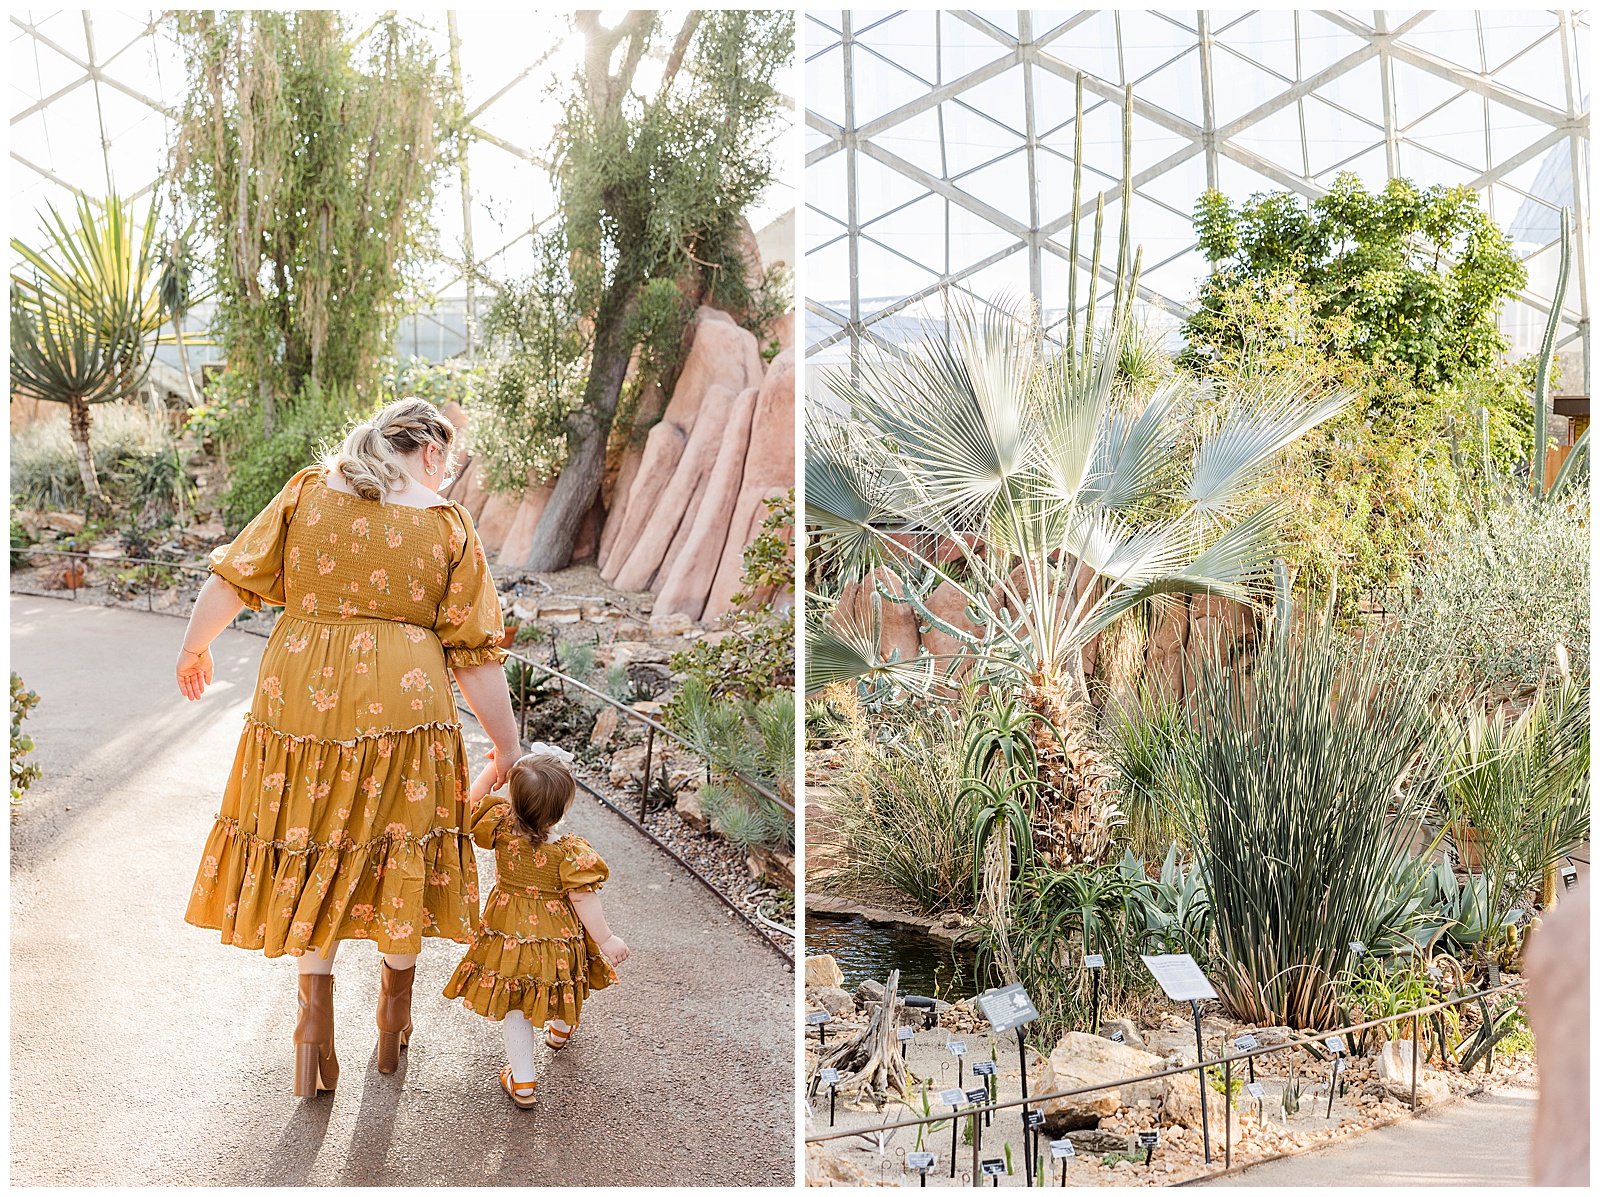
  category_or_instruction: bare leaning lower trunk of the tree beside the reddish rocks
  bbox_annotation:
[522,282,634,573]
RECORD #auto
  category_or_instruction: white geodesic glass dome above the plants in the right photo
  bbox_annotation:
[805,10,1589,392]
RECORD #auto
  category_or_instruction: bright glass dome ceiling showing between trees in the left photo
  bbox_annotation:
[11,8,795,358]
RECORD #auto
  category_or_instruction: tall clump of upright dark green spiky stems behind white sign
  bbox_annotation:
[1173,627,1453,1027]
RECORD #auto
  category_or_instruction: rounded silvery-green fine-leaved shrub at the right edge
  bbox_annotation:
[1394,498,1592,698]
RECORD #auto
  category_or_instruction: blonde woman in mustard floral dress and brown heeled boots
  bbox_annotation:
[178,398,518,1096]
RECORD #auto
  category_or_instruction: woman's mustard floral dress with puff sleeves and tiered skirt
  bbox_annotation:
[186,466,506,955]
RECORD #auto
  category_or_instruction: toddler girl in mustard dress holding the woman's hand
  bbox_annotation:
[445,744,629,1109]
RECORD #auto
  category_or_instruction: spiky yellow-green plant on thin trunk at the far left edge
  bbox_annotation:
[11,195,165,502]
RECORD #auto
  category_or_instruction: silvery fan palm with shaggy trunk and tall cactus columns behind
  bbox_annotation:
[806,82,1346,864]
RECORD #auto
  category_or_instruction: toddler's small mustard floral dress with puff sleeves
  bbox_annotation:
[445,797,616,1026]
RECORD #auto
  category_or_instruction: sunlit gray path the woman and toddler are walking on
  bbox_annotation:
[10,594,795,1186]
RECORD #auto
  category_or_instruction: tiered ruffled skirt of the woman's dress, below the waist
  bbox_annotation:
[186,613,478,955]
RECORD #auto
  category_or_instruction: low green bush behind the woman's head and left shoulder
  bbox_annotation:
[221,382,381,530]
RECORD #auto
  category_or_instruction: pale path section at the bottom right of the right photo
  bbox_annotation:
[1202,1088,1539,1189]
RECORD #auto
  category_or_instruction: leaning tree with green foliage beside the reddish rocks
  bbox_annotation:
[523,10,794,570]
